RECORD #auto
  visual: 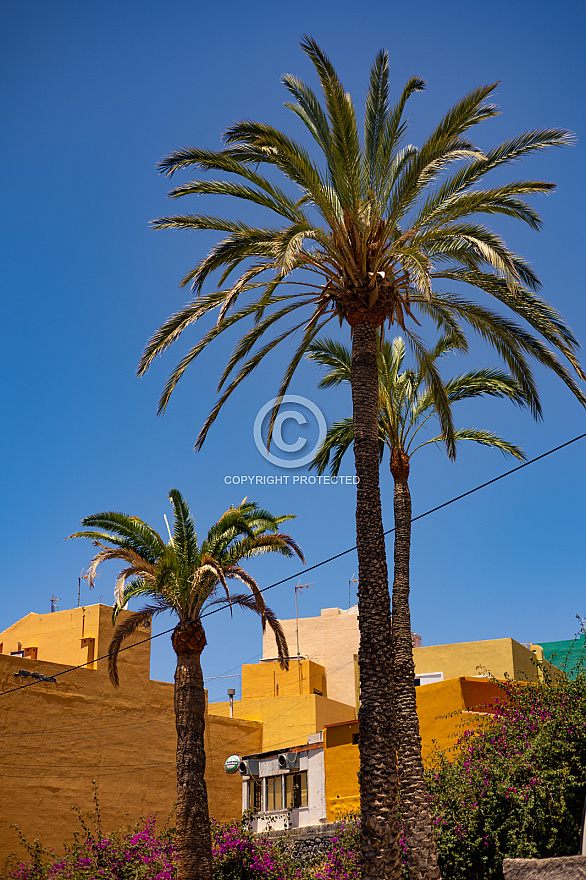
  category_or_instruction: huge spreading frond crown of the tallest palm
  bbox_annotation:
[139,36,586,454]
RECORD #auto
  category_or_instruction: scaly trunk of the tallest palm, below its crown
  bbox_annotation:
[351,323,402,880]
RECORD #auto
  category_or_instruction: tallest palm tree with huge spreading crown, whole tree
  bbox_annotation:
[138,37,586,880]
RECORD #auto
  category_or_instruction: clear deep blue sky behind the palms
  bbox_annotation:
[0,0,586,699]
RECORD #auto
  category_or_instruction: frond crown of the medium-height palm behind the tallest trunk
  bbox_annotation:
[307,336,527,475]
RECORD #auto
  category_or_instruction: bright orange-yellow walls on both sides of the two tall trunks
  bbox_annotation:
[324,676,502,822]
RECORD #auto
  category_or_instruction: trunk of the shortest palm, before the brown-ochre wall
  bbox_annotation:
[172,620,212,880]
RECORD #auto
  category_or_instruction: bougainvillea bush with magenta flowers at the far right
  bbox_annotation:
[427,674,586,880]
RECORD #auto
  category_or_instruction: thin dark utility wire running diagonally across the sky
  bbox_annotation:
[0,433,586,696]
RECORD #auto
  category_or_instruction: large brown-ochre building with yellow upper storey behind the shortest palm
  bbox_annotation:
[0,606,262,873]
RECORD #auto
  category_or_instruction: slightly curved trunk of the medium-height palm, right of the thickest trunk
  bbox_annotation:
[391,449,440,880]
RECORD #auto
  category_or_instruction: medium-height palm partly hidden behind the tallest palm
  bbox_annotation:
[307,336,528,878]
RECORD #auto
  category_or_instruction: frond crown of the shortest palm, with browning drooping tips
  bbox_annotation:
[70,489,303,683]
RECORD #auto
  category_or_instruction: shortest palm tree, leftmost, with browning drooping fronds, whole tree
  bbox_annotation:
[70,489,303,880]
